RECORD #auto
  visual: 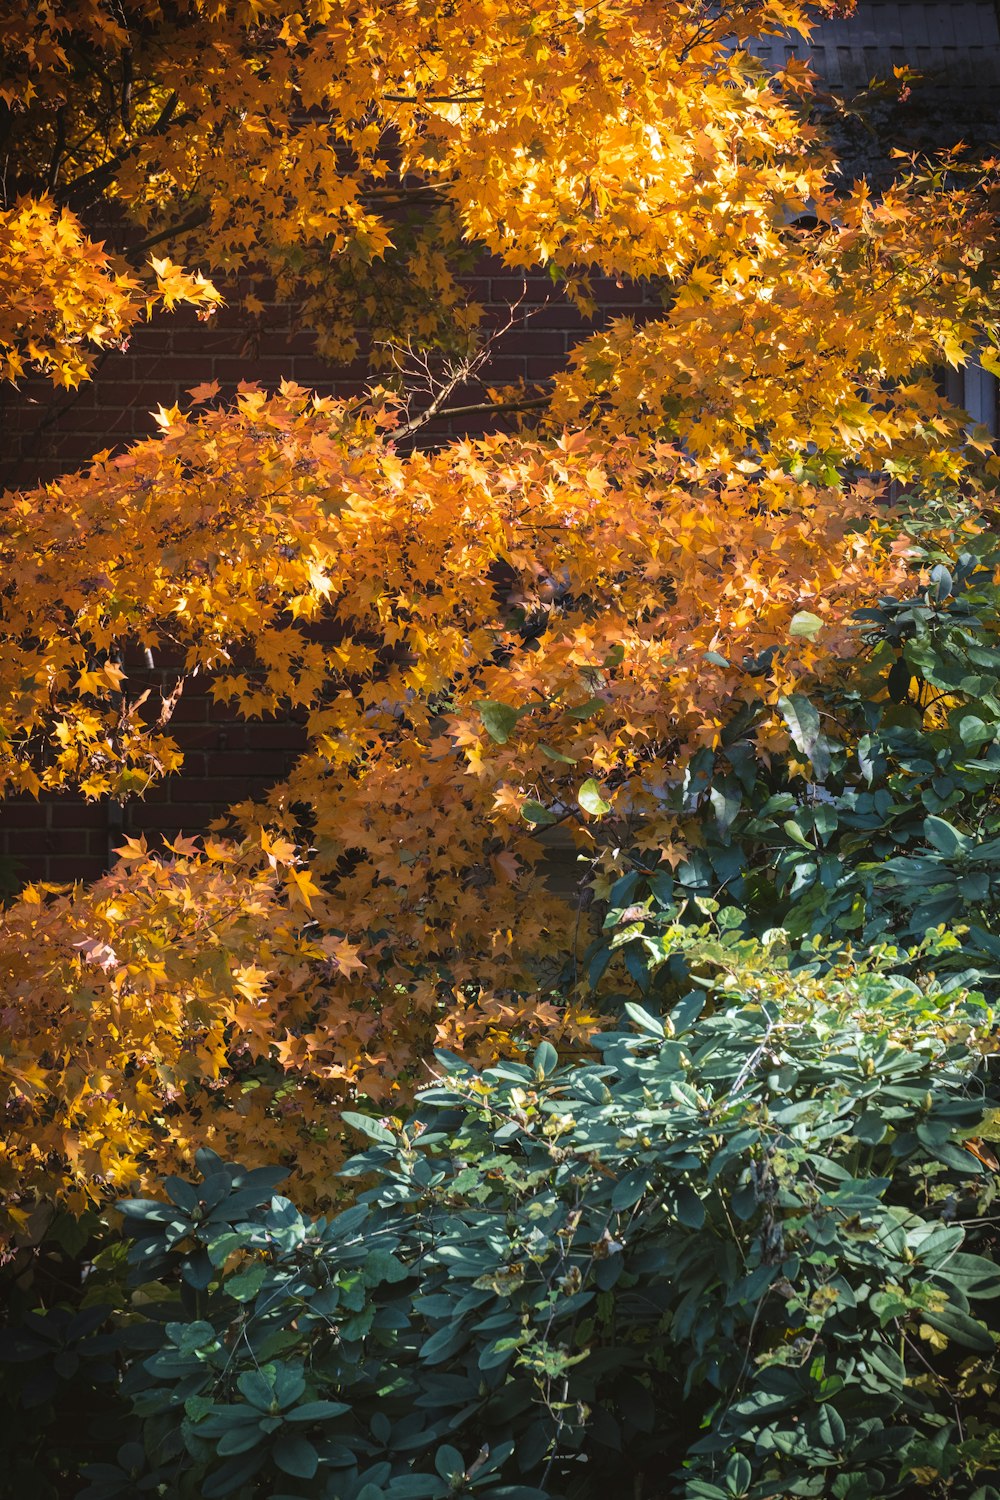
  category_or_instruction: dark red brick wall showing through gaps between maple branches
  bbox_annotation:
[0,266,657,885]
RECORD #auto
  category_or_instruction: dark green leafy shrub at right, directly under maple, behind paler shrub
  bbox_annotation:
[602,522,1000,972]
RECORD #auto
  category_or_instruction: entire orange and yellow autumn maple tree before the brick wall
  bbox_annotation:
[0,0,997,1215]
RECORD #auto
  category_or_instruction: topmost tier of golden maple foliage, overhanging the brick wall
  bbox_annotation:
[9,0,983,405]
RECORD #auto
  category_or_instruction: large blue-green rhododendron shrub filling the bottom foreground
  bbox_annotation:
[7,917,1000,1500]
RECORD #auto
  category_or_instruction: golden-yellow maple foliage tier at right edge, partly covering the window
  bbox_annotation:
[552,173,999,486]
